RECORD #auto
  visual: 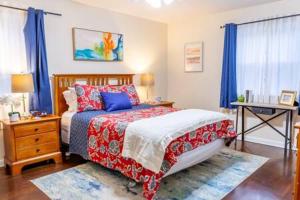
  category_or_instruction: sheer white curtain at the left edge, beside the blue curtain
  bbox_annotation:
[0,8,28,119]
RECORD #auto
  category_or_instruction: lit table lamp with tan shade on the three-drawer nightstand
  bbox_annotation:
[11,74,34,114]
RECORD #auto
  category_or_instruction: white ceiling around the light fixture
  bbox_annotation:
[73,0,279,23]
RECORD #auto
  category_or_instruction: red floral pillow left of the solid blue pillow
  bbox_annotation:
[75,84,102,112]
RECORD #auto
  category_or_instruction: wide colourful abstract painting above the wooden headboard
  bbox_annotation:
[73,28,124,62]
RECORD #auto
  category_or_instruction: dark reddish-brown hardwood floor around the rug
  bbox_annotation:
[0,143,296,200]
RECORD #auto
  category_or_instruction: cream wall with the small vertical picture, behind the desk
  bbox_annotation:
[168,0,300,146]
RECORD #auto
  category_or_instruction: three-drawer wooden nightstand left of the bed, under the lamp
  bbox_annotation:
[2,115,62,176]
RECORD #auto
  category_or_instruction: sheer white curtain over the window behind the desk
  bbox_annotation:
[237,17,300,103]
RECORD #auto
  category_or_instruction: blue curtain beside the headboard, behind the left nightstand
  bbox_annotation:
[24,8,52,113]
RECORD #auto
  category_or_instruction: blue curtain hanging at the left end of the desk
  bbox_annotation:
[220,24,237,109]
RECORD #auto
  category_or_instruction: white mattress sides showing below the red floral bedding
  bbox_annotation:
[61,111,225,177]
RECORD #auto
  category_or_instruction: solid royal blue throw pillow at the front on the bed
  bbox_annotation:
[100,92,132,112]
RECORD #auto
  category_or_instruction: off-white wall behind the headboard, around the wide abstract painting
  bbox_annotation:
[0,0,167,164]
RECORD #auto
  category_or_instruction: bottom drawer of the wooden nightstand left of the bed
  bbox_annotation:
[17,142,58,160]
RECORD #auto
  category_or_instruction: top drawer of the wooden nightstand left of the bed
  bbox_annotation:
[14,121,56,137]
